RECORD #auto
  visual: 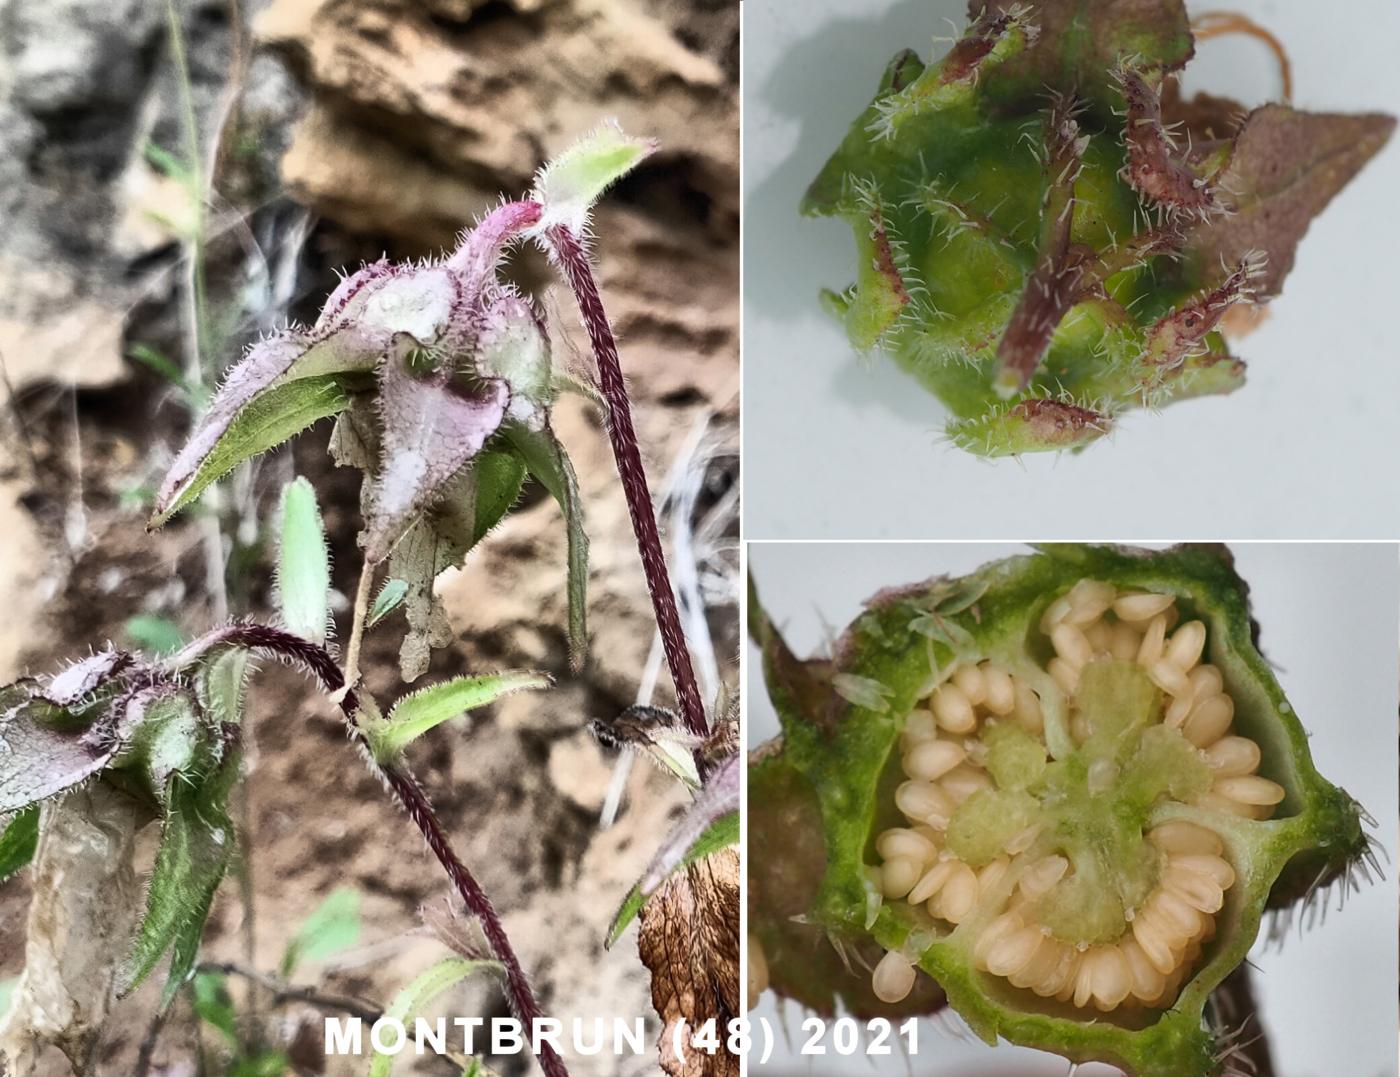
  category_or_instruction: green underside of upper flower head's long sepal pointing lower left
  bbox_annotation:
[150,374,350,527]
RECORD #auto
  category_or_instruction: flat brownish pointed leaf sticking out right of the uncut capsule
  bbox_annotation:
[1184,105,1396,298]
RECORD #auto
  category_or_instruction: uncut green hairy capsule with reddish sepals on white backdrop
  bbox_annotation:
[802,0,1394,457]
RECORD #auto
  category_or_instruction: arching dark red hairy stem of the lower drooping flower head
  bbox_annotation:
[186,625,568,1077]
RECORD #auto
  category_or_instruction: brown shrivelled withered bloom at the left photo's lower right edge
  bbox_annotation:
[637,849,741,1077]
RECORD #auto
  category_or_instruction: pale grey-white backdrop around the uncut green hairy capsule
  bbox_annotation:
[743,0,1400,539]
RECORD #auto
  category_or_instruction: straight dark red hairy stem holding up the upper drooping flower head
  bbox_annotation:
[545,224,708,750]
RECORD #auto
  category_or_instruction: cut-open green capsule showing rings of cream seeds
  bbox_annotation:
[749,546,1372,1077]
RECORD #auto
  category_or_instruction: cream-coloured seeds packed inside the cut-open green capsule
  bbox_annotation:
[872,580,1284,1013]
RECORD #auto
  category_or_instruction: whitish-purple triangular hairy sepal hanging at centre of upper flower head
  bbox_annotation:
[363,339,511,564]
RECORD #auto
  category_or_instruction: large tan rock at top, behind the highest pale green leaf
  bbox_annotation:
[256,0,738,246]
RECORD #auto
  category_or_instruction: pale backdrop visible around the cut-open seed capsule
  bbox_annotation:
[746,543,1400,1077]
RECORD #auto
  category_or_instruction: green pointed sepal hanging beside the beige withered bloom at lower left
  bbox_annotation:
[122,753,238,994]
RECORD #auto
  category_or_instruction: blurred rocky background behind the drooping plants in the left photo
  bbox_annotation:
[0,0,739,1076]
